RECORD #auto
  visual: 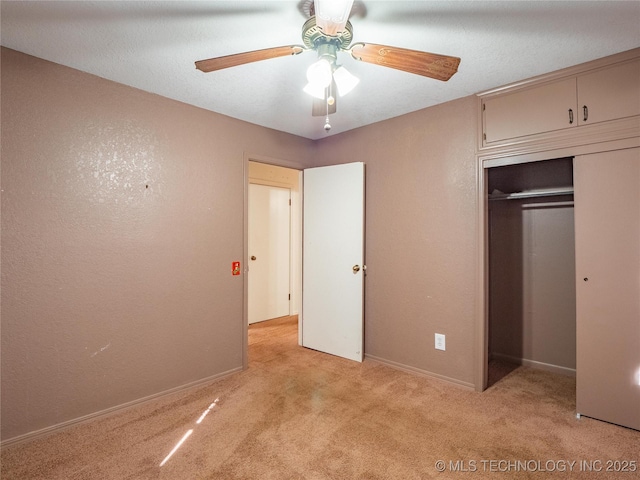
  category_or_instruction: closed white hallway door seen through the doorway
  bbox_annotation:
[248,184,291,323]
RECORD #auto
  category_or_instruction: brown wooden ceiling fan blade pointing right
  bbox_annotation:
[349,43,460,82]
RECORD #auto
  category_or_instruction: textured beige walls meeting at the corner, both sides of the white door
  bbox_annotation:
[2,49,477,440]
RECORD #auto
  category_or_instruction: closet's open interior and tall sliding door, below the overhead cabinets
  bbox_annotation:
[487,151,640,430]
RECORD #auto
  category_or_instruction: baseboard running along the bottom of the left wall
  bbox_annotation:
[0,367,242,449]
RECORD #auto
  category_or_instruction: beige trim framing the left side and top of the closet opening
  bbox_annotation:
[473,137,640,392]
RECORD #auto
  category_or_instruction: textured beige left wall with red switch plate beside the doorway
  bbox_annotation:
[1,49,313,440]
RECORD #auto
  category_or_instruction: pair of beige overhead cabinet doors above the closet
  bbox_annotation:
[482,58,640,146]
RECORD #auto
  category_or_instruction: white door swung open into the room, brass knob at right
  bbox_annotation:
[302,163,365,362]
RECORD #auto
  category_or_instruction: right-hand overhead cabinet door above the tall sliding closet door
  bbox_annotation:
[578,59,640,125]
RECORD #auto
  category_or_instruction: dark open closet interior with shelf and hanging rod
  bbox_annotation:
[487,157,576,387]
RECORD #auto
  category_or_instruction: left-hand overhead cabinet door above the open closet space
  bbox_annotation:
[483,78,577,144]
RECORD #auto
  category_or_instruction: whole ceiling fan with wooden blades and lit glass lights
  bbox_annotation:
[196,0,460,132]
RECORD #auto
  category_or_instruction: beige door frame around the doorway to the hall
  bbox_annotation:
[241,152,308,370]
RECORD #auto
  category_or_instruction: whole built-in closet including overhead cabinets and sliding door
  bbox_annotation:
[477,48,640,430]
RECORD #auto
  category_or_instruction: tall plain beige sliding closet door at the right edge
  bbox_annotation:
[574,148,640,430]
